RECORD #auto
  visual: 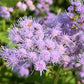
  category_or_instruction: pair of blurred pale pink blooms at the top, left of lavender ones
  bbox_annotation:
[16,0,35,11]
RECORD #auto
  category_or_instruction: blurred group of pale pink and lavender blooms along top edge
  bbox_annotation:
[16,0,53,14]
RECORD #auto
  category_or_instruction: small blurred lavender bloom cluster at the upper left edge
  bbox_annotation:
[0,6,13,19]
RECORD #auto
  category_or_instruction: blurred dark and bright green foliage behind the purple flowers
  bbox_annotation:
[0,0,80,84]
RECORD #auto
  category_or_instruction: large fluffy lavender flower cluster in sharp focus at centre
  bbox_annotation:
[2,14,81,76]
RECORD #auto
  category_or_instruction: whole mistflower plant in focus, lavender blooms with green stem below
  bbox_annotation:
[1,2,84,84]
